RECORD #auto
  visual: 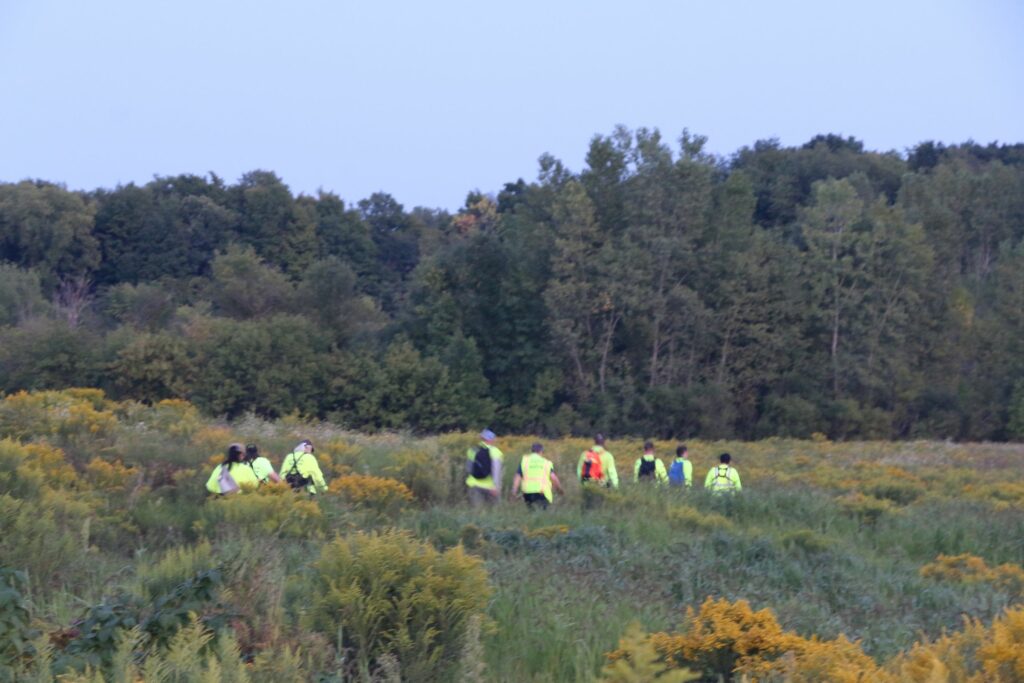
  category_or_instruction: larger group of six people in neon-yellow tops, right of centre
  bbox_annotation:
[466,429,742,508]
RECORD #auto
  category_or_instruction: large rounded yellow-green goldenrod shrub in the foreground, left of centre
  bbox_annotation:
[307,531,490,681]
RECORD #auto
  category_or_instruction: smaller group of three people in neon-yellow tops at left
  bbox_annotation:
[206,439,327,495]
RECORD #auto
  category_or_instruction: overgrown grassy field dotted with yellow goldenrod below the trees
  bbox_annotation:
[0,390,1024,682]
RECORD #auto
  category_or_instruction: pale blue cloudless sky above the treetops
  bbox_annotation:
[0,0,1024,211]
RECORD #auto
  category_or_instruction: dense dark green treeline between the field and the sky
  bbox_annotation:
[0,129,1024,440]
